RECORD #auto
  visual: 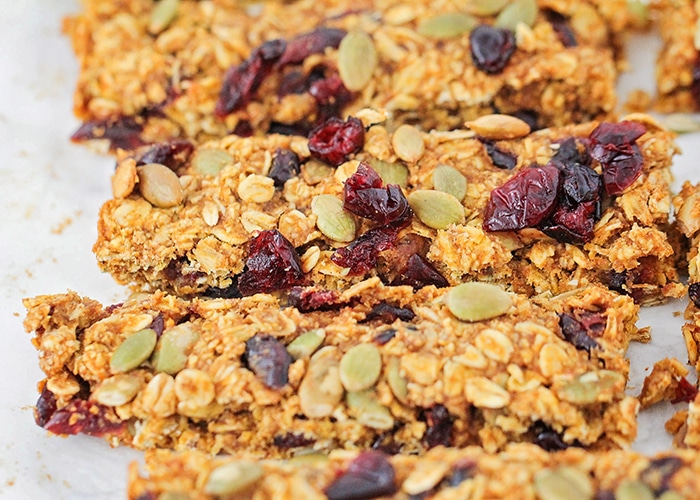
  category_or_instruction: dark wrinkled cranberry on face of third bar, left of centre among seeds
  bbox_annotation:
[245,333,292,389]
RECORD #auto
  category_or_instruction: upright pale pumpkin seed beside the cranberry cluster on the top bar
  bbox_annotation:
[338,31,379,92]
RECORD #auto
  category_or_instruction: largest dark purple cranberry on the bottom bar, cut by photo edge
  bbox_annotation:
[324,451,398,500]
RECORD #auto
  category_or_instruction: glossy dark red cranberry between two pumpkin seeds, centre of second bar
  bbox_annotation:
[343,162,413,225]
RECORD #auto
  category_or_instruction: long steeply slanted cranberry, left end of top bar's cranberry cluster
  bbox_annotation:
[214,39,287,118]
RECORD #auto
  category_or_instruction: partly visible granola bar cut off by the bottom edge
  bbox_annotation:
[128,444,700,500]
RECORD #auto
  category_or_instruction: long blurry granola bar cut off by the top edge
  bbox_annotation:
[65,0,629,149]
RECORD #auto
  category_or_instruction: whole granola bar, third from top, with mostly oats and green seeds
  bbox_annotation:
[25,278,638,458]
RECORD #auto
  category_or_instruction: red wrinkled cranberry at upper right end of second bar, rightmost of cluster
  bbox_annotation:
[590,121,646,195]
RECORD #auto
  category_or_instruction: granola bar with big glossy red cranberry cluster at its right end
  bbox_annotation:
[94,110,685,304]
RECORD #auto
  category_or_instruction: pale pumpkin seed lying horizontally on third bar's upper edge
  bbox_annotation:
[445,281,513,321]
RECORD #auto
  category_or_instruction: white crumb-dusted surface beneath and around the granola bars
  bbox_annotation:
[0,0,700,499]
